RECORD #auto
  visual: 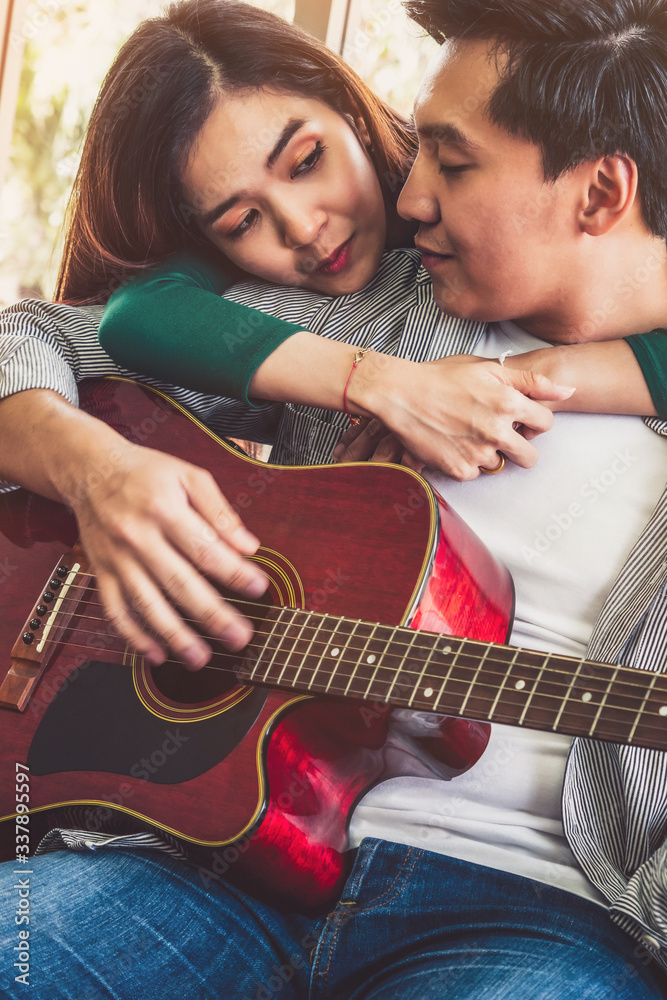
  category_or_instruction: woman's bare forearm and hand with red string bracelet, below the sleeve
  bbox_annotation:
[250,333,571,480]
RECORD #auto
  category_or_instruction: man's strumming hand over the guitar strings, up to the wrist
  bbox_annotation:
[70,445,267,669]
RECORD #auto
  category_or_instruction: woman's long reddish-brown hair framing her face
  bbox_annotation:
[56,0,416,304]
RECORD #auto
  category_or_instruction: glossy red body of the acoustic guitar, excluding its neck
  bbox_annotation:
[0,379,513,912]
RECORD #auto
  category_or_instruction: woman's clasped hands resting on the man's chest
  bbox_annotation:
[334,355,574,480]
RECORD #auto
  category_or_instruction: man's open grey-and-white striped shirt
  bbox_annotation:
[0,250,667,967]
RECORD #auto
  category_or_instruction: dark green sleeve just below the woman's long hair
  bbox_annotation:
[99,253,301,405]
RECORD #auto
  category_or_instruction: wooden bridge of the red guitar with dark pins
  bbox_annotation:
[0,546,88,712]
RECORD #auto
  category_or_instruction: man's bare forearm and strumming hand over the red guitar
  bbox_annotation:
[0,389,267,669]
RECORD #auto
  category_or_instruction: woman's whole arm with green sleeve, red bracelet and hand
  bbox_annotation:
[100,255,576,479]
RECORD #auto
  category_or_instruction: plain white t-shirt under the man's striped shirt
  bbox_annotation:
[350,323,667,902]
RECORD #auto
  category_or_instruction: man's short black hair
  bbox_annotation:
[405,0,667,239]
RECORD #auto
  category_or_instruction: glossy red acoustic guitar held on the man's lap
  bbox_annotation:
[0,378,667,912]
